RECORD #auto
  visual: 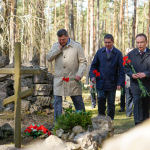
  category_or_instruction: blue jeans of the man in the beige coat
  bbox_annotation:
[54,95,85,121]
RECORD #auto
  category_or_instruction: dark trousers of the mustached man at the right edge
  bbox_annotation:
[132,93,150,124]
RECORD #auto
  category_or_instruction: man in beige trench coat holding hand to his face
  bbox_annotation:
[47,29,87,121]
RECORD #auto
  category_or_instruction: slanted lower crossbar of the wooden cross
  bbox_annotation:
[3,87,33,106]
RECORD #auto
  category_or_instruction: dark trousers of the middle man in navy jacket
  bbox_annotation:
[97,89,116,120]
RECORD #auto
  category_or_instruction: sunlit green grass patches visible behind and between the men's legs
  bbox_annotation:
[67,93,134,135]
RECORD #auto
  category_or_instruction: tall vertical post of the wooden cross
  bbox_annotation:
[14,42,21,148]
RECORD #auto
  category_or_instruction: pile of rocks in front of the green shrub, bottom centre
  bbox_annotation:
[49,116,114,150]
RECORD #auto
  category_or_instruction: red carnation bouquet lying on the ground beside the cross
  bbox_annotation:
[24,124,51,138]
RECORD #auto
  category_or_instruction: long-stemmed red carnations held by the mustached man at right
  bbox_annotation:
[123,56,150,97]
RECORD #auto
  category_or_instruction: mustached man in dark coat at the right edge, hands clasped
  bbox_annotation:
[124,33,150,125]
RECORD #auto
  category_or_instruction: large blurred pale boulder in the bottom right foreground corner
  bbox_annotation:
[103,119,150,150]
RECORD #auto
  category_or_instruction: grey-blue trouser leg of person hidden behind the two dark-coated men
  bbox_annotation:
[125,87,133,117]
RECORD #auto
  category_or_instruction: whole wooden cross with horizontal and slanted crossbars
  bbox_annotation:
[0,42,41,148]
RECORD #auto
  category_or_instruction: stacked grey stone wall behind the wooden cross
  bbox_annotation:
[0,56,53,113]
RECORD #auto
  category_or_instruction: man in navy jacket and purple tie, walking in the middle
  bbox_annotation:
[90,34,125,120]
